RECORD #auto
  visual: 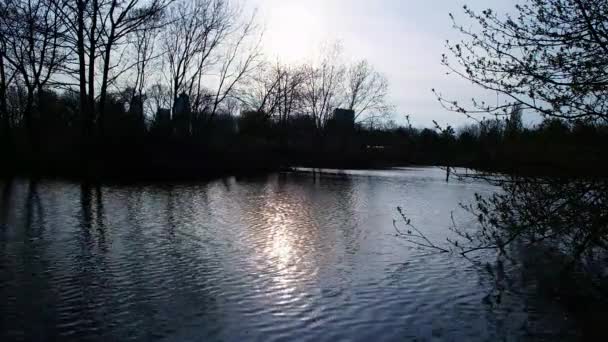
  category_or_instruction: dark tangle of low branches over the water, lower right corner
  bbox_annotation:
[470,176,608,336]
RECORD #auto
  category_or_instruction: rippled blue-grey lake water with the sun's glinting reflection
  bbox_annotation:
[0,168,572,341]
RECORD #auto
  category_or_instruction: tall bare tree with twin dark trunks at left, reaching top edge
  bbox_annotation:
[49,0,166,138]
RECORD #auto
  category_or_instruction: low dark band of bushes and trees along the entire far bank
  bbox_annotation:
[3,83,608,178]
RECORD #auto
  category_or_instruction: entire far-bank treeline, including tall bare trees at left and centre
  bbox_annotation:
[0,0,606,178]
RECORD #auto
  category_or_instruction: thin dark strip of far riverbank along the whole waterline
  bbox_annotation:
[0,153,608,183]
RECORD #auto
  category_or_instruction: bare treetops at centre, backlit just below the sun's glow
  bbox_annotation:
[246,56,391,131]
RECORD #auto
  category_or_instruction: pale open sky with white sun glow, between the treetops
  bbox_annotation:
[249,0,515,126]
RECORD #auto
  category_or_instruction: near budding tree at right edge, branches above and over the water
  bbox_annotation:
[401,0,608,296]
